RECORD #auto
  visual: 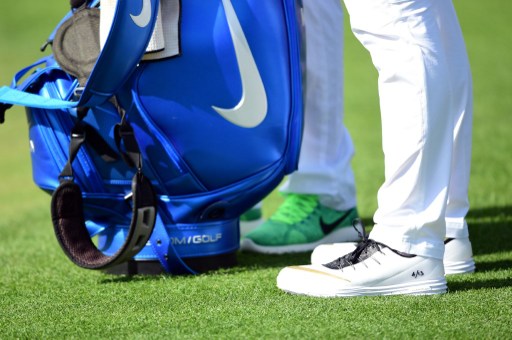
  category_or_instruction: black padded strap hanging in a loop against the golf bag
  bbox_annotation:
[51,118,156,269]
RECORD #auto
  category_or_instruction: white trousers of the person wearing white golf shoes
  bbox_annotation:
[342,0,473,258]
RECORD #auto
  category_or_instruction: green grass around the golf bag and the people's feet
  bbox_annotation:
[0,0,512,339]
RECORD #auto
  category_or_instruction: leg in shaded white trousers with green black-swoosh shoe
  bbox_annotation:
[241,0,358,253]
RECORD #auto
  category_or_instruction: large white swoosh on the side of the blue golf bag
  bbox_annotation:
[212,0,268,128]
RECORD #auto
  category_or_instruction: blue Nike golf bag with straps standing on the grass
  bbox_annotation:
[0,0,302,274]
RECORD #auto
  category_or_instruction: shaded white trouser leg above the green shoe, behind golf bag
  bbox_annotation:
[281,0,356,210]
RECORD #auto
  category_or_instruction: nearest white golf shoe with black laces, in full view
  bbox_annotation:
[277,237,447,297]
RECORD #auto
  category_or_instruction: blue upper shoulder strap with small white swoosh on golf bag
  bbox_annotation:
[0,0,159,109]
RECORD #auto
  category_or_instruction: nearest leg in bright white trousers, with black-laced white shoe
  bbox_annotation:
[277,0,469,296]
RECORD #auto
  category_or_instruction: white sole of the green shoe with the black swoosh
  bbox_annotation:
[240,226,359,254]
